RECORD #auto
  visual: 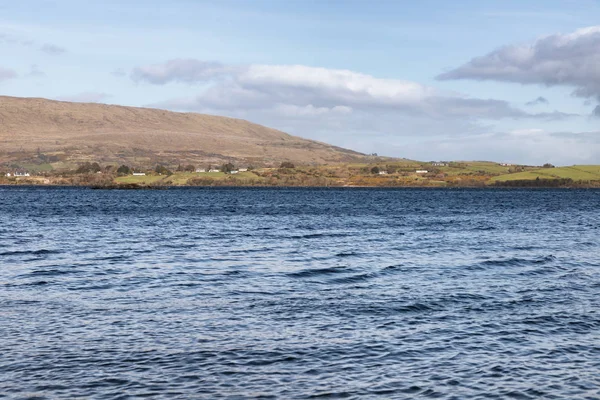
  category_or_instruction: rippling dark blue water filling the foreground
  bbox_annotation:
[0,188,600,399]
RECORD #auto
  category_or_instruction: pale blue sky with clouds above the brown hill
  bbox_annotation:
[0,0,600,165]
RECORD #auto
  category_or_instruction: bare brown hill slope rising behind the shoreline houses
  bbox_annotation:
[0,96,363,164]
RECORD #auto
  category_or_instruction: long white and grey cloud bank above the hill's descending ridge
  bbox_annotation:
[131,59,567,120]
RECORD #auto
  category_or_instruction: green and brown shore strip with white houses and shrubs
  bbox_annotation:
[0,162,600,189]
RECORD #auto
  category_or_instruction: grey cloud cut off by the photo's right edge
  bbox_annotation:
[437,26,600,101]
